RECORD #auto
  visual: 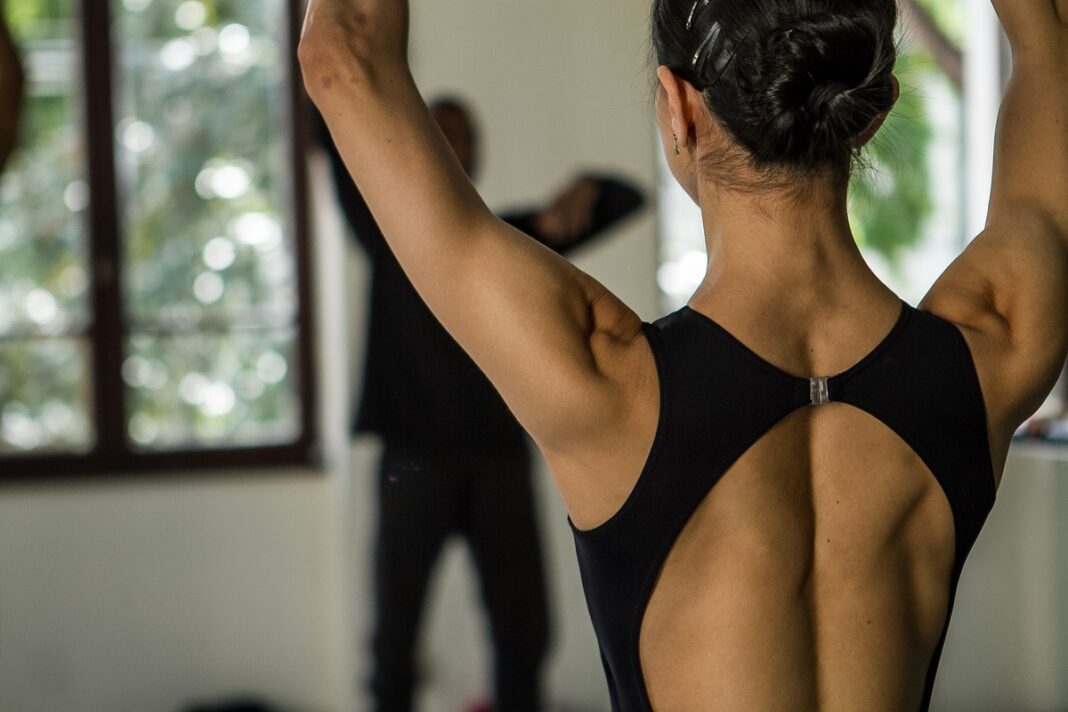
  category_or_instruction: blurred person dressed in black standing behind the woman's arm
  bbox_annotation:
[320,97,644,712]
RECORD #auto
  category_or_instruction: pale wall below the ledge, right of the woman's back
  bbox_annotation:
[931,445,1068,712]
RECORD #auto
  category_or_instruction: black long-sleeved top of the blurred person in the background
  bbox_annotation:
[320,118,644,453]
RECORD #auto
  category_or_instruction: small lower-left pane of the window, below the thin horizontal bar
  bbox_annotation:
[0,338,93,455]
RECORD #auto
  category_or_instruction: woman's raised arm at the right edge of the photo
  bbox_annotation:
[924,0,1068,434]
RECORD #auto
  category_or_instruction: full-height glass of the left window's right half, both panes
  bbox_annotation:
[112,0,300,449]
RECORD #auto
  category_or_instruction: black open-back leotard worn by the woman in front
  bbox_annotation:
[568,301,995,712]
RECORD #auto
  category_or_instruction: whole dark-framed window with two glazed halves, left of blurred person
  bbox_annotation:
[0,0,314,476]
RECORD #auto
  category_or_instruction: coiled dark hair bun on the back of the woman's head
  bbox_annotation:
[750,13,892,163]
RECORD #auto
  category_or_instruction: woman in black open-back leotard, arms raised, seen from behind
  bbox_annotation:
[299,0,1068,712]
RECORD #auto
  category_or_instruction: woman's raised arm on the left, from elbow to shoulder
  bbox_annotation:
[299,0,641,449]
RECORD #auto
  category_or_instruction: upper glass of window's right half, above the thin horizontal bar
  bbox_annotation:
[115,0,296,328]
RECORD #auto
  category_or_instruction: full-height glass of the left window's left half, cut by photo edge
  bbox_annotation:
[0,0,94,454]
